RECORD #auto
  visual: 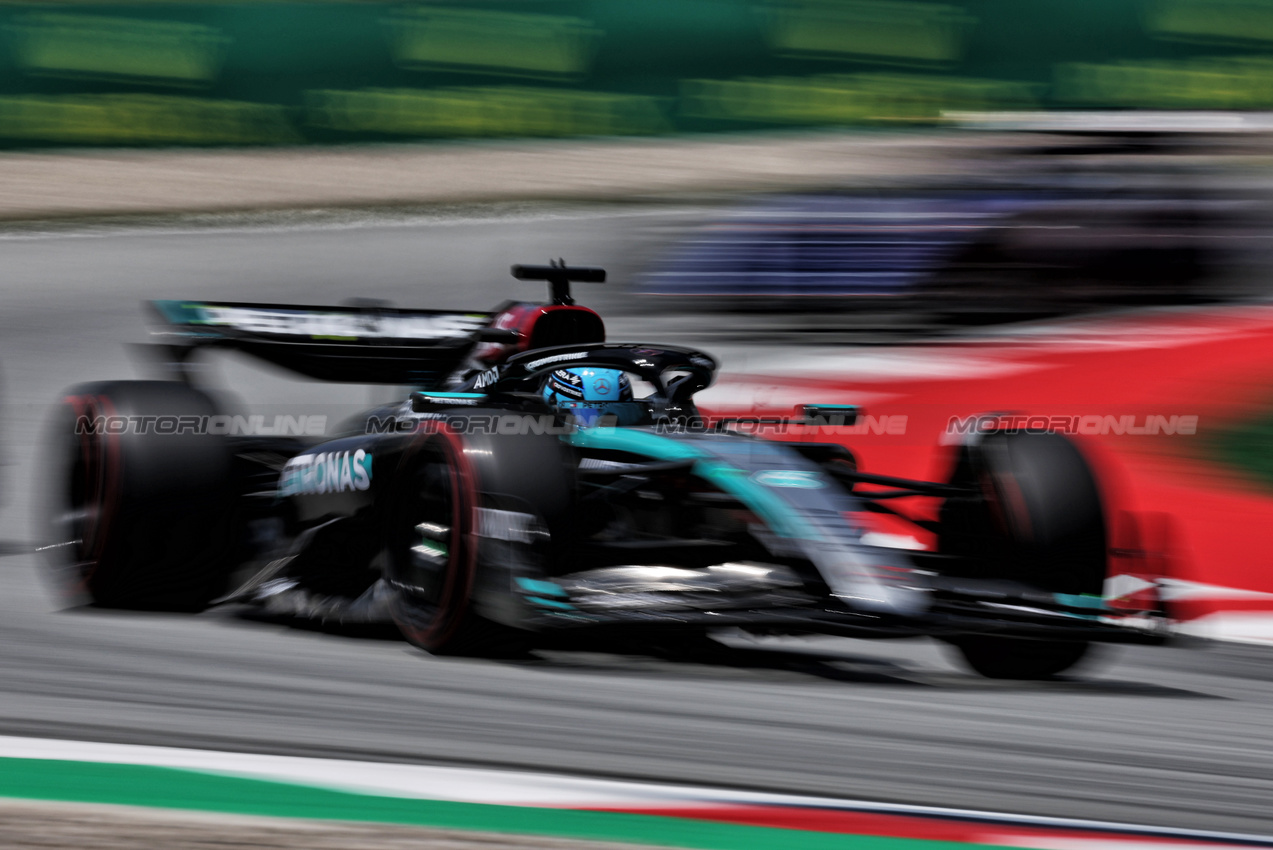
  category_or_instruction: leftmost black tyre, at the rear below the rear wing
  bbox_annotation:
[43,380,241,611]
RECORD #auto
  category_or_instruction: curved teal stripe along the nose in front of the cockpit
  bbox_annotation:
[565,428,822,540]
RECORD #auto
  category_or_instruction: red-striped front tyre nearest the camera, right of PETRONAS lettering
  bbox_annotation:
[386,419,570,658]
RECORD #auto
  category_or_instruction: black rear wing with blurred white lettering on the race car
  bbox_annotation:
[149,300,494,386]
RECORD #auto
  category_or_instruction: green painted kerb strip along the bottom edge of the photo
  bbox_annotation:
[0,758,969,850]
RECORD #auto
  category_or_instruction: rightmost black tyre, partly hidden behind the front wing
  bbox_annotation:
[938,431,1106,678]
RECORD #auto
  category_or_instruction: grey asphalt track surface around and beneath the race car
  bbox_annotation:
[0,207,1273,833]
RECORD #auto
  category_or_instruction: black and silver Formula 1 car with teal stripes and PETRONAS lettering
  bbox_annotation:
[46,263,1166,678]
